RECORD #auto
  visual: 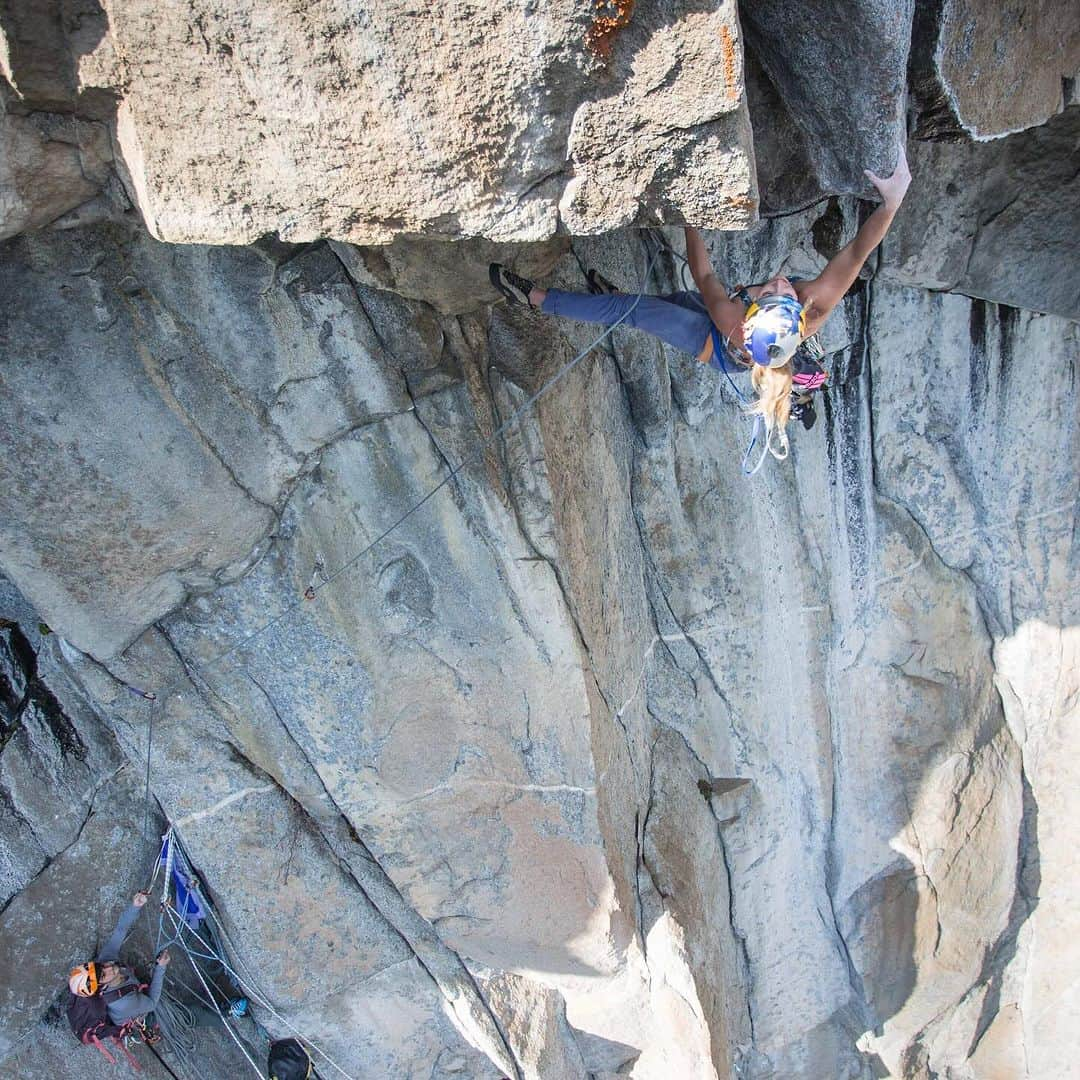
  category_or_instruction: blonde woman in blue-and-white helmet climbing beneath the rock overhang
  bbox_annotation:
[489,144,912,459]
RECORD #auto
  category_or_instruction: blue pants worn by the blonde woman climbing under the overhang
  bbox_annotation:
[540,288,713,356]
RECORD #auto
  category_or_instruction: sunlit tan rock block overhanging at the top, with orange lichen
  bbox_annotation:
[12,0,756,244]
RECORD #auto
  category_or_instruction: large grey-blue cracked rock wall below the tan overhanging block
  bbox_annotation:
[0,204,1078,1080]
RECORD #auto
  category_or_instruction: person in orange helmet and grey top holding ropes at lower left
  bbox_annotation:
[67,892,170,1061]
